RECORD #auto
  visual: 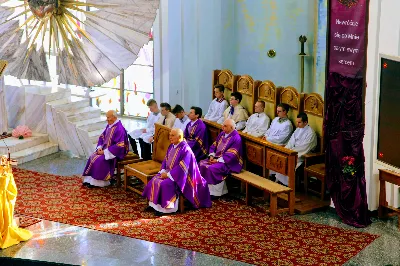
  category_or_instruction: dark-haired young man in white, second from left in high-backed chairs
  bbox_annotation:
[218,92,249,130]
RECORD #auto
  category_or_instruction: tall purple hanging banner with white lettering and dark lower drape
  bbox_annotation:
[324,0,371,227]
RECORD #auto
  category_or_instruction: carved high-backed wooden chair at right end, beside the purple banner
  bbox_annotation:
[304,93,326,200]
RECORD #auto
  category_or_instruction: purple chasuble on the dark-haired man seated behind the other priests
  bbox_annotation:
[183,119,208,162]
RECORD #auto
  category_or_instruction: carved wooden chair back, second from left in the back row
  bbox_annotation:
[236,75,260,116]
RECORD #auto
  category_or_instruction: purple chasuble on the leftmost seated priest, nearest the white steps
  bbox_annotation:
[83,121,129,180]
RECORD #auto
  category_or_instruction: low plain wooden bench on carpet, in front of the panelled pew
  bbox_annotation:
[231,171,294,217]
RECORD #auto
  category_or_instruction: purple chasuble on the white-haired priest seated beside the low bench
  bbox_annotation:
[199,130,243,185]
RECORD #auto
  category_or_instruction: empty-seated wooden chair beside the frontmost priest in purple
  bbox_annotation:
[124,123,171,194]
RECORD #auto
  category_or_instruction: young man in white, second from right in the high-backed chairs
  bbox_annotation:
[264,103,293,145]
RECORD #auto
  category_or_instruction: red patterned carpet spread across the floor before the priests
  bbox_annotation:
[14,169,378,265]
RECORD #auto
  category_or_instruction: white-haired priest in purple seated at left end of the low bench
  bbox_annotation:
[199,119,243,197]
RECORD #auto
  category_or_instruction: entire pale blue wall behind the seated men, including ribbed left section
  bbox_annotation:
[154,0,318,112]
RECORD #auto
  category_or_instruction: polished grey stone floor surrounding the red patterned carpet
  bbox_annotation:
[0,113,400,266]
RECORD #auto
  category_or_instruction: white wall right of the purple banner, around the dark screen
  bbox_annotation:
[364,0,400,210]
